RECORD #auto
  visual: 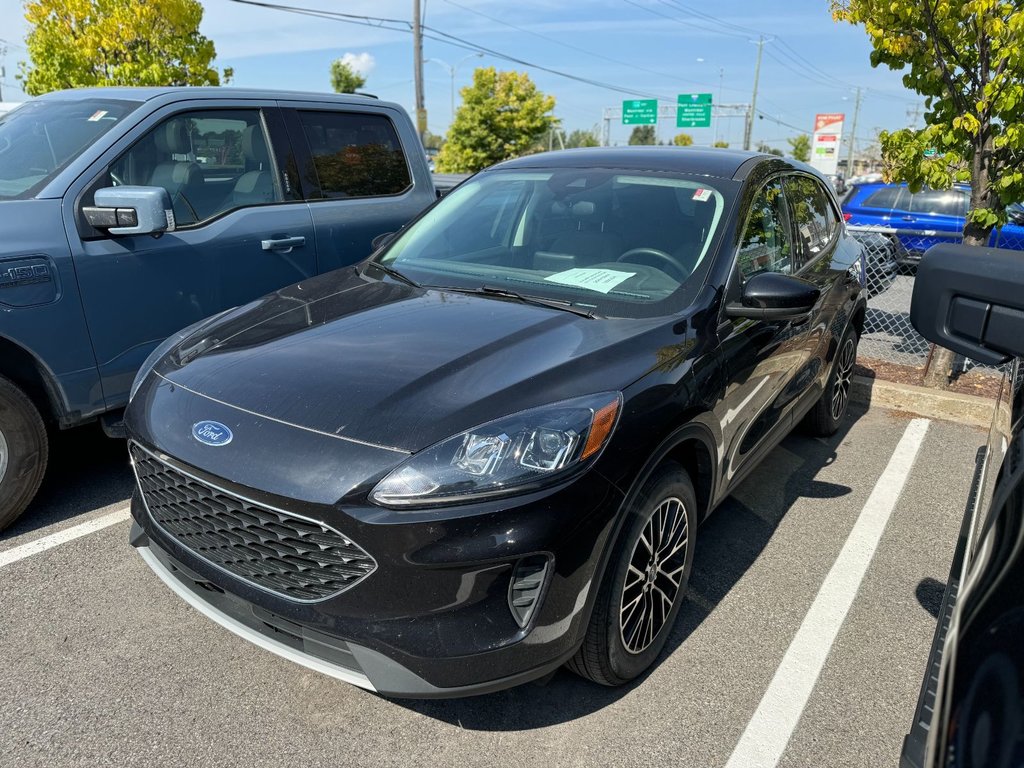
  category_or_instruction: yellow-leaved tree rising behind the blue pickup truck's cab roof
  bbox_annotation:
[18,0,231,96]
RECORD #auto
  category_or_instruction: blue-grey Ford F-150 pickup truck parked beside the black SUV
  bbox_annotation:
[0,83,436,530]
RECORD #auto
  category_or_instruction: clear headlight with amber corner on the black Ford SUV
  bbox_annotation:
[370,392,622,507]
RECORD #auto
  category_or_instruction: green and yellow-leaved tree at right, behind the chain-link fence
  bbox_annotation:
[831,0,1024,387]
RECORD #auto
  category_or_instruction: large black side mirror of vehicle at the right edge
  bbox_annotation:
[910,243,1024,366]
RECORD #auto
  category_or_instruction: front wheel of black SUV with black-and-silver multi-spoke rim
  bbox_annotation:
[568,462,696,686]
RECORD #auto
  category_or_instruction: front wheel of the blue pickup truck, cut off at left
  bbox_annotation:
[0,376,48,530]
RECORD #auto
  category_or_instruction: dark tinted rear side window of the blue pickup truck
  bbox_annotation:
[299,111,412,200]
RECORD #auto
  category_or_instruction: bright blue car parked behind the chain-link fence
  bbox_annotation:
[843,183,1024,267]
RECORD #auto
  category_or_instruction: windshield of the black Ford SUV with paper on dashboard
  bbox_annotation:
[379,168,735,317]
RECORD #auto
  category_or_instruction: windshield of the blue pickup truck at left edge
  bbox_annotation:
[0,98,138,200]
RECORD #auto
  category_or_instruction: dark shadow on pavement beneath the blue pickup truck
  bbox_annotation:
[0,424,133,542]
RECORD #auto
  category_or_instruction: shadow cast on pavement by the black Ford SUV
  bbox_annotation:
[394,404,866,731]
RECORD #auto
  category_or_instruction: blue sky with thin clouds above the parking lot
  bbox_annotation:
[0,0,921,153]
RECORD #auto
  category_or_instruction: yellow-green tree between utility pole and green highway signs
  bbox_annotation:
[437,67,556,173]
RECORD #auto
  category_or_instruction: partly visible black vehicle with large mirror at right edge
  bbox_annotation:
[900,245,1024,768]
